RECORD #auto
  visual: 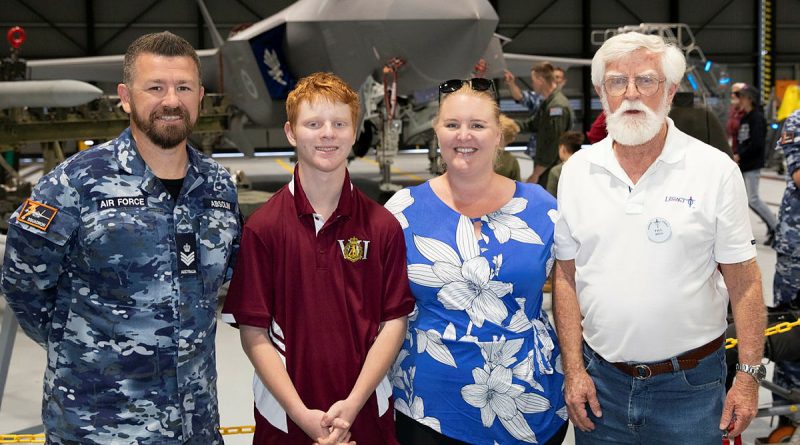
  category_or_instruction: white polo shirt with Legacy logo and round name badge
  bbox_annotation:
[555,119,756,362]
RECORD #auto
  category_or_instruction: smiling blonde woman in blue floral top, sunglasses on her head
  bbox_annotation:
[386,79,567,445]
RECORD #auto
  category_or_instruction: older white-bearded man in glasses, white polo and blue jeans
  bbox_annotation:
[554,33,764,445]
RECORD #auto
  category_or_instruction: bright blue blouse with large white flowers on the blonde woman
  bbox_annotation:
[386,182,567,445]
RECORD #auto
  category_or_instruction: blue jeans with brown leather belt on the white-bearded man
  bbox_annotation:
[575,344,726,445]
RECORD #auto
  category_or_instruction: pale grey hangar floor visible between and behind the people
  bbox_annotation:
[0,153,785,445]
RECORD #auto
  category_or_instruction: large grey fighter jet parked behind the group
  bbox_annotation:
[12,0,498,154]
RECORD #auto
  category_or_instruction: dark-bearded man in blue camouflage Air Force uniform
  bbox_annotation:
[2,32,241,445]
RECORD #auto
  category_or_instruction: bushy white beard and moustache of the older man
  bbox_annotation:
[600,94,670,145]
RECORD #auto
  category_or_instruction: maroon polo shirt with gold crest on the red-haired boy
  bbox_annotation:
[222,166,414,445]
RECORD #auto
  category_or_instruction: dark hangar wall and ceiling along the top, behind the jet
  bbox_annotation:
[6,0,800,77]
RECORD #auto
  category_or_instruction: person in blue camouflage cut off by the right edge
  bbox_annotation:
[770,110,800,406]
